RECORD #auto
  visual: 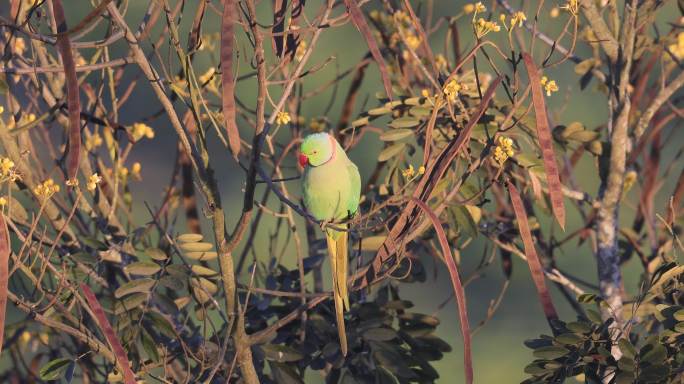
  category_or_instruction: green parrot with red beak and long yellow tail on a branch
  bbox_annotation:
[299,132,361,356]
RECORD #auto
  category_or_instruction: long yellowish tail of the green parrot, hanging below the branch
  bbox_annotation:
[325,224,349,356]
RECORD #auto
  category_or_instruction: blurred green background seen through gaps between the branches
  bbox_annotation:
[10,0,682,383]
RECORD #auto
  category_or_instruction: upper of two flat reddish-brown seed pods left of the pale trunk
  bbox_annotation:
[523,53,565,230]
